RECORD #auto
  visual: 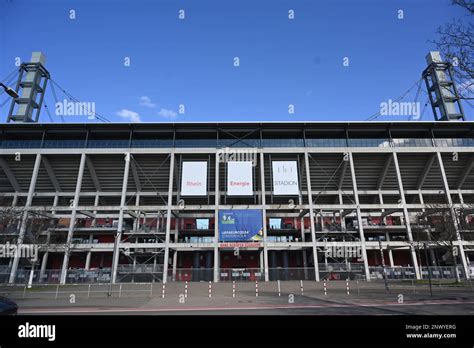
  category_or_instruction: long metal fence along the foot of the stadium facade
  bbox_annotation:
[0,263,466,284]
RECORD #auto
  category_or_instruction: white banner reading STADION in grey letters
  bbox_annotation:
[272,161,300,195]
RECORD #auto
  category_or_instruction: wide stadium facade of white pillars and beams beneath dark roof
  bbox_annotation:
[0,121,474,283]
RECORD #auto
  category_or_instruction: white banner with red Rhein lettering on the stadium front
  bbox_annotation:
[181,162,207,196]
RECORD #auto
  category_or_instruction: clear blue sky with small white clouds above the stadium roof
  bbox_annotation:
[0,0,472,122]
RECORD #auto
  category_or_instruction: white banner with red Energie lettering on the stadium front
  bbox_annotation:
[227,161,253,196]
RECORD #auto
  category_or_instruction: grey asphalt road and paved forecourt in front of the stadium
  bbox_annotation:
[4,282,474,315]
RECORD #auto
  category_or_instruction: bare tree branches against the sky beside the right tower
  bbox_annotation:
[432,0,474,99]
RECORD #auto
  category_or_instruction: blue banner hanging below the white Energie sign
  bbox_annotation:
[219,209,263,242]
